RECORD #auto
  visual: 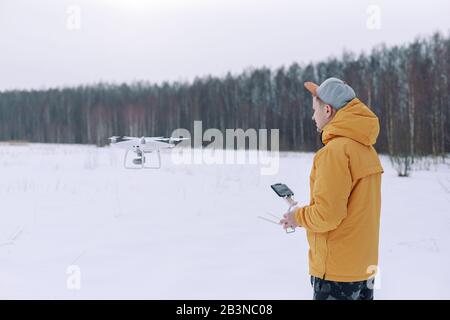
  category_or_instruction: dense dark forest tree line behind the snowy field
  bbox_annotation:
[0,33,450,159]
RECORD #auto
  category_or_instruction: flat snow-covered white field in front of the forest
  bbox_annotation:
[0,144,450,299]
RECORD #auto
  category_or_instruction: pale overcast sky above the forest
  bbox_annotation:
[0,0,450,90]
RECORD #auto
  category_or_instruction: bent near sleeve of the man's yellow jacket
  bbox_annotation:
[295,148,352,232]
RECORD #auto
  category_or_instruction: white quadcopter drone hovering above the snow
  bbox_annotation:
[109,136,189,169]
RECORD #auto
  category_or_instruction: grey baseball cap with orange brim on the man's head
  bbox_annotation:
[305,78,356,110]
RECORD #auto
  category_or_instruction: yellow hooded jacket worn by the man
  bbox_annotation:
[295,98,383,282]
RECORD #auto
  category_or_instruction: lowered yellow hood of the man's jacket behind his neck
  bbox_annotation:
[322,98,380,146]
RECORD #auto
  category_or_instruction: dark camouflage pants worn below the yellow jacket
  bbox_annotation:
[311,276,375,300]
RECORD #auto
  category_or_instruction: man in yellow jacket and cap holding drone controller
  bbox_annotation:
[280,78,383,300]
